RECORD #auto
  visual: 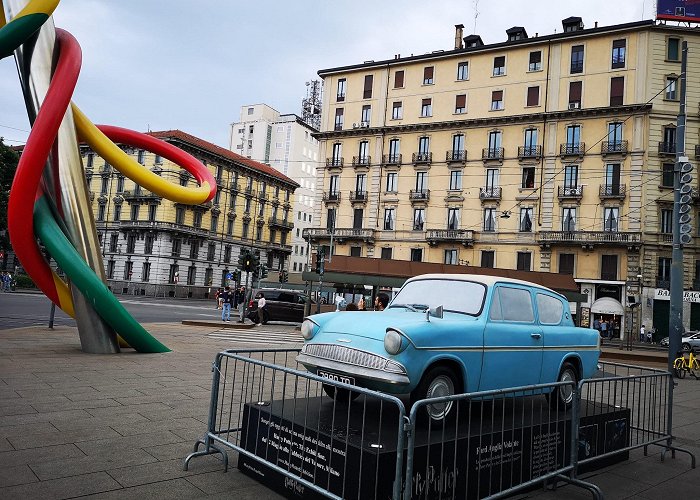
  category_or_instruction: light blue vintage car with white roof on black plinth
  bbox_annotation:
[297,274,600,422]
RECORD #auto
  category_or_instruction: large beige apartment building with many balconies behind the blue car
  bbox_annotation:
[305,17,700,336]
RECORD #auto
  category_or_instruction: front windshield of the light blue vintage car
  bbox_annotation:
[389,279,486,316]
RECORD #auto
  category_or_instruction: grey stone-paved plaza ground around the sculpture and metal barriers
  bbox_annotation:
[0,323,700,500]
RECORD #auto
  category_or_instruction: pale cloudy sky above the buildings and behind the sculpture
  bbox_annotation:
[0,0,655,151]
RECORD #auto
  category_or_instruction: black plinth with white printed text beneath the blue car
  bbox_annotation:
[238,396,630,499]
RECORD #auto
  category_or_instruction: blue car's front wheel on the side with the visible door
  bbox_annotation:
[411,366,462,427]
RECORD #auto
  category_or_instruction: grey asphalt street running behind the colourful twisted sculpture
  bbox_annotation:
[0,292,235,330]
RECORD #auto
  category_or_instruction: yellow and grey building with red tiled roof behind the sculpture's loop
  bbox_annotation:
[81,130,298,297]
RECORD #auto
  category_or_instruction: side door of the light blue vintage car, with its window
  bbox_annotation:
[479,283,543,391]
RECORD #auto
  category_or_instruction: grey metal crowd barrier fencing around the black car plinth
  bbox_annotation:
[184,349,695,500]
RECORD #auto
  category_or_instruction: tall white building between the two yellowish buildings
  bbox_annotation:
[230,104,319,283]
